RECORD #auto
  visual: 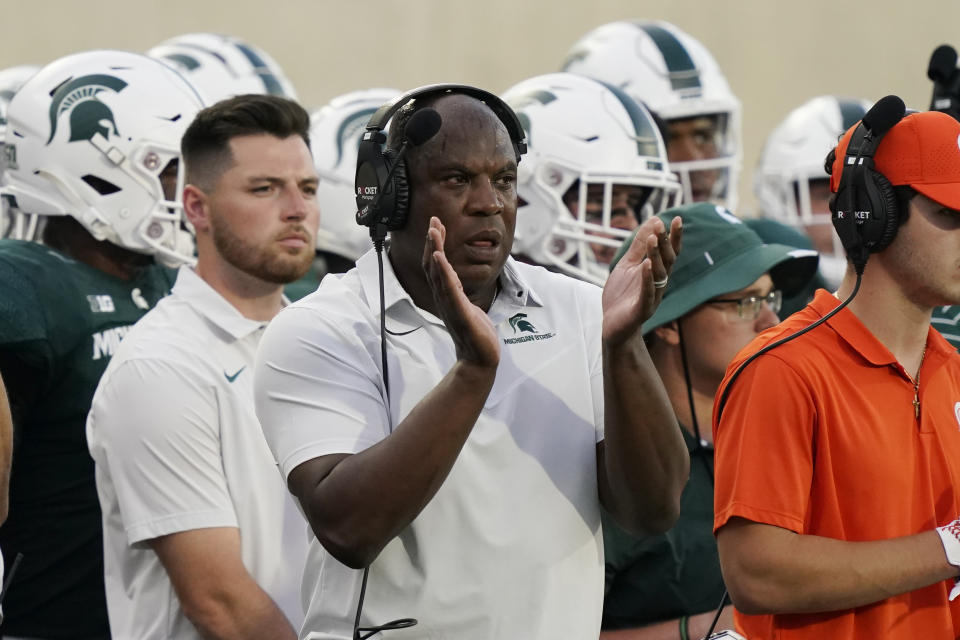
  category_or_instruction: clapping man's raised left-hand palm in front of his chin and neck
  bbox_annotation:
[422,216,500,368]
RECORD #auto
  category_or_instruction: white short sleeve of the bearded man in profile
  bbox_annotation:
[88,360,238,545]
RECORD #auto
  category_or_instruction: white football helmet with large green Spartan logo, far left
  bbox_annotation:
[0,51,203,265]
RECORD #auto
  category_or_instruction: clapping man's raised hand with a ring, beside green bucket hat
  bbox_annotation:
[603,216,683,345]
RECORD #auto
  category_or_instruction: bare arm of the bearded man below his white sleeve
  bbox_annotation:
[148,527,297,640]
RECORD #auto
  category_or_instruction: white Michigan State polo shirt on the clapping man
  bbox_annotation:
[255,251,604,640]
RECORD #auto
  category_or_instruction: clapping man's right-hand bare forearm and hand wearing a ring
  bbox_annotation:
[597,217,690,532]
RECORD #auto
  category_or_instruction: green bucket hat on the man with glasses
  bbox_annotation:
[610,202,819,333]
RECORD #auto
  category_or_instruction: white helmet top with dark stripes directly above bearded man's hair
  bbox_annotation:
[147,33,297,105]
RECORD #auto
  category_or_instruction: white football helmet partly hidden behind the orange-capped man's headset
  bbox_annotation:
[753,96,870,284]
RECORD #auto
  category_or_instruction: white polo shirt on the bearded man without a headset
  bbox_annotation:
[87,267,308,640]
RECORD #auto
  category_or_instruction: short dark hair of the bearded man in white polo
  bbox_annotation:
[180,94,310,191]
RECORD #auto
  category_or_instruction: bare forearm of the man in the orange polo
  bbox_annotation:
[717,518,958,614]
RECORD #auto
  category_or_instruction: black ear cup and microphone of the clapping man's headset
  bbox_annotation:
[357,108,443,241]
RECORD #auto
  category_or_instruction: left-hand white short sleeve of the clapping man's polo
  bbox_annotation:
[254,307,388,478]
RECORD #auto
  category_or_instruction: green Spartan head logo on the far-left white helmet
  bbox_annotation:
[47,74,127,144]
